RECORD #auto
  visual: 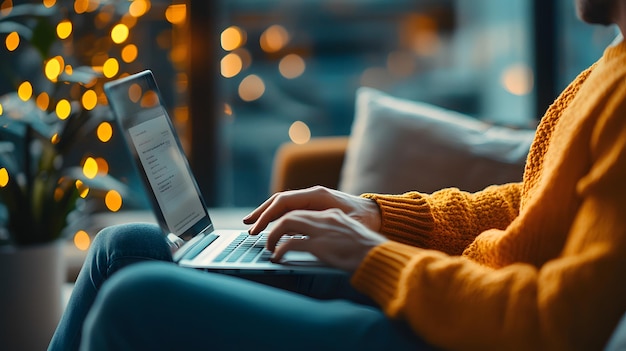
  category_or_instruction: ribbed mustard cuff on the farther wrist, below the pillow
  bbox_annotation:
[361,192,435,242]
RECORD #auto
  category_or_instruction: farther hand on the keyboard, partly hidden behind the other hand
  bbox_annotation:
[243,186,381,235]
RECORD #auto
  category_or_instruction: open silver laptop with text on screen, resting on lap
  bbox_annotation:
[104,70,345,274]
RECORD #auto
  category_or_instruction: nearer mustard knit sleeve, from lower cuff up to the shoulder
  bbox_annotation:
[352,72,626,350]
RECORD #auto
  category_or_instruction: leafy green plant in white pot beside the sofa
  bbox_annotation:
[0,4,136,349]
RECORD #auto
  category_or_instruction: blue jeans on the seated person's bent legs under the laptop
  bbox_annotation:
[49,224,431,350]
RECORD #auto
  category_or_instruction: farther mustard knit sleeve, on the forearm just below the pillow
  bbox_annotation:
[361,183,522,255]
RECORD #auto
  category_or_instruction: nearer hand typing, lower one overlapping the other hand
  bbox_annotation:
[267,208,388,272]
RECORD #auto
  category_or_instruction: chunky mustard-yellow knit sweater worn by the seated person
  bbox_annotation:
[352,43,626,350]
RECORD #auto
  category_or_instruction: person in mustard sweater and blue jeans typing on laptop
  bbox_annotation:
[51,0,626,350]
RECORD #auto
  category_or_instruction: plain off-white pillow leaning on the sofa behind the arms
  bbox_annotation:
[339,87,534,195]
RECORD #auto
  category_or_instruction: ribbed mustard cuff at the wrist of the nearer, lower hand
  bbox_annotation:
[351,240,416,317]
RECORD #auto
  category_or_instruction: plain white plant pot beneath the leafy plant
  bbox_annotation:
[0,240,65,351]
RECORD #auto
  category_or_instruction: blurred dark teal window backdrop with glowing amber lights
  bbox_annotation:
[0,0,616,250]
